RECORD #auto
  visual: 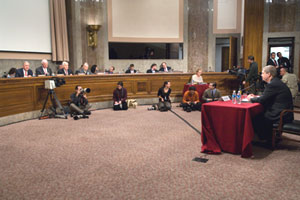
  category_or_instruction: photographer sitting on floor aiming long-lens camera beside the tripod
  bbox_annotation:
[70,85,91,120]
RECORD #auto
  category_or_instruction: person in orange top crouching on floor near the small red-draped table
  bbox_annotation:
[182,86,201,112]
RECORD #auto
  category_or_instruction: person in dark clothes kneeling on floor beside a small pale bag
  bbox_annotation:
[113,81,128,110]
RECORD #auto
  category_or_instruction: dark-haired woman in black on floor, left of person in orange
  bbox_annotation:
[157,81,172,111]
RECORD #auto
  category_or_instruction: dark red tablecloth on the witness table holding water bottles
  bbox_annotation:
[201,101,263,157]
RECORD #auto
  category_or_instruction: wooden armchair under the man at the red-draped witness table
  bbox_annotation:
[272,110,300,149]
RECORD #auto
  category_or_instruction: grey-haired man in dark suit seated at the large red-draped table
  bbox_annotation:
[248,65,294,145]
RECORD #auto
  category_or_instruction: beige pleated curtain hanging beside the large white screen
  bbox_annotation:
[50,0,69,61]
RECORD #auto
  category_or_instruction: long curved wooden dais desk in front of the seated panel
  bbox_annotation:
[0,72,237,119]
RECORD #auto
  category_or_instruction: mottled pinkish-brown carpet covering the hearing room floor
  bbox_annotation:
[0,106,300,200]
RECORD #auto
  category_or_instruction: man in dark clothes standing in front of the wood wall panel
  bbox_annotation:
[243,56,258,94]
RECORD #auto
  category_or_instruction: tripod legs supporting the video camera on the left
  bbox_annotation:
[39,89,68,119]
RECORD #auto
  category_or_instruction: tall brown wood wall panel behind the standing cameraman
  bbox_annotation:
[243,0,264,71]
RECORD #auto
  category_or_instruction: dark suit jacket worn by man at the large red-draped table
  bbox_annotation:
[251,77,293,122]
